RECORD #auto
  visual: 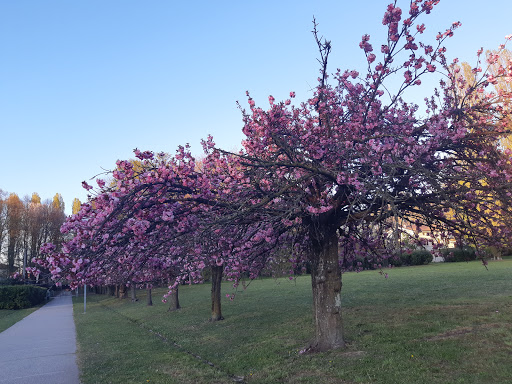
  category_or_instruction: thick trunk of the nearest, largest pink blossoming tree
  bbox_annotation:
[311,232,345,351]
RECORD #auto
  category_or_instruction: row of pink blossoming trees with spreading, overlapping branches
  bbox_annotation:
[33,0,512,351]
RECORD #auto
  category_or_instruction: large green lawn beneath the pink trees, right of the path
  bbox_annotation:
[74,260,512,384]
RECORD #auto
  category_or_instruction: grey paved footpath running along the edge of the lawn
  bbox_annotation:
[0,292,80,384]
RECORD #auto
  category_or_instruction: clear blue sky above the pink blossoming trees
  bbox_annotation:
[0,0,512,213]
